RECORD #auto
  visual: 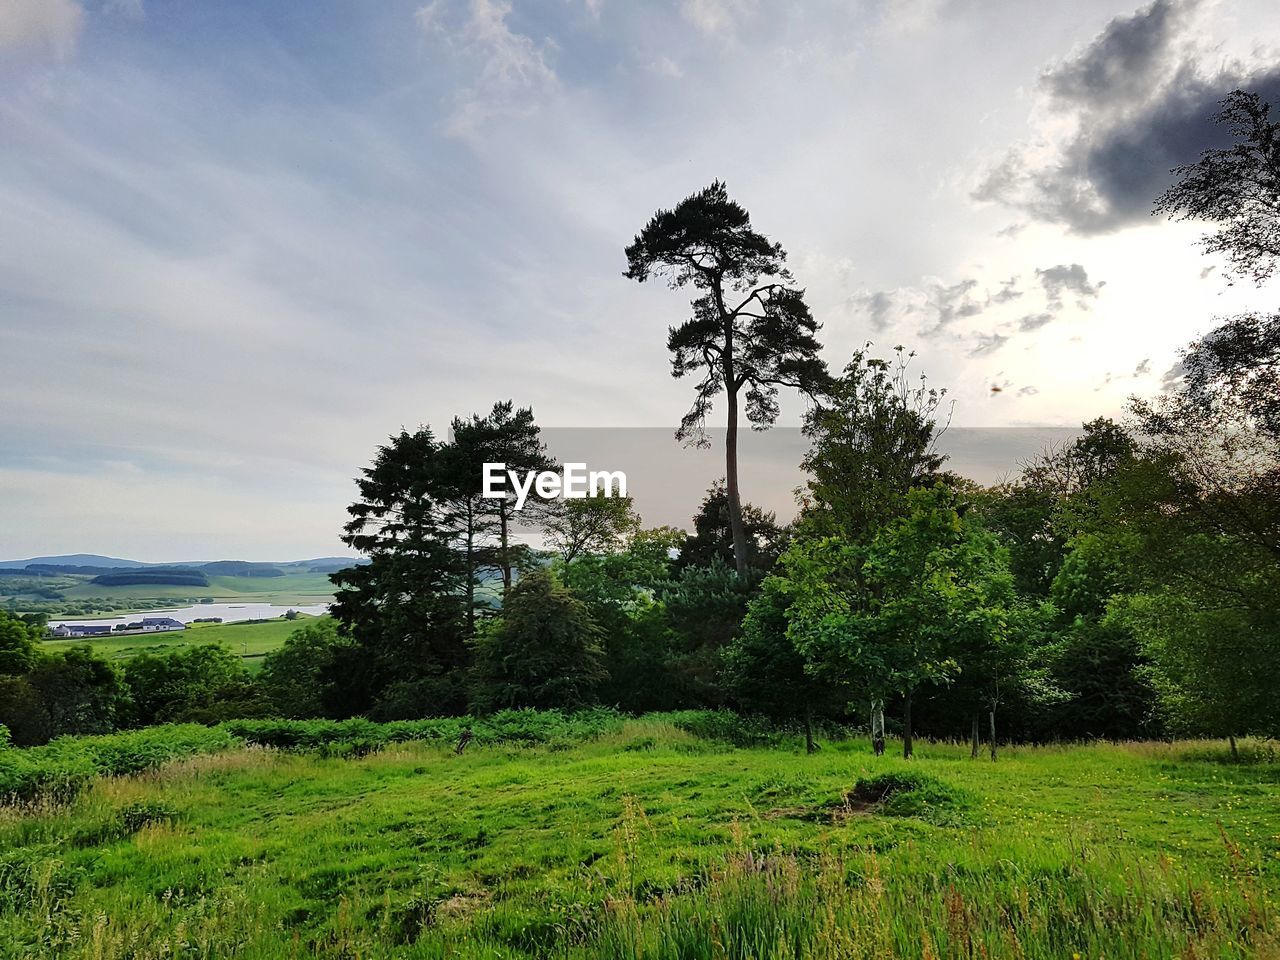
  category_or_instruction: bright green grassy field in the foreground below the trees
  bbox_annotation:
[0,718,1280,960]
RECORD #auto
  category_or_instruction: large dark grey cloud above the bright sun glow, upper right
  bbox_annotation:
[973,0,1280,234]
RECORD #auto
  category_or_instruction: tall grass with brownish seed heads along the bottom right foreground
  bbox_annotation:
[593,849,1280,960]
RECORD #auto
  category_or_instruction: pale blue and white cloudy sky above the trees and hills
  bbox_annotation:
[0,0,1280,561]
